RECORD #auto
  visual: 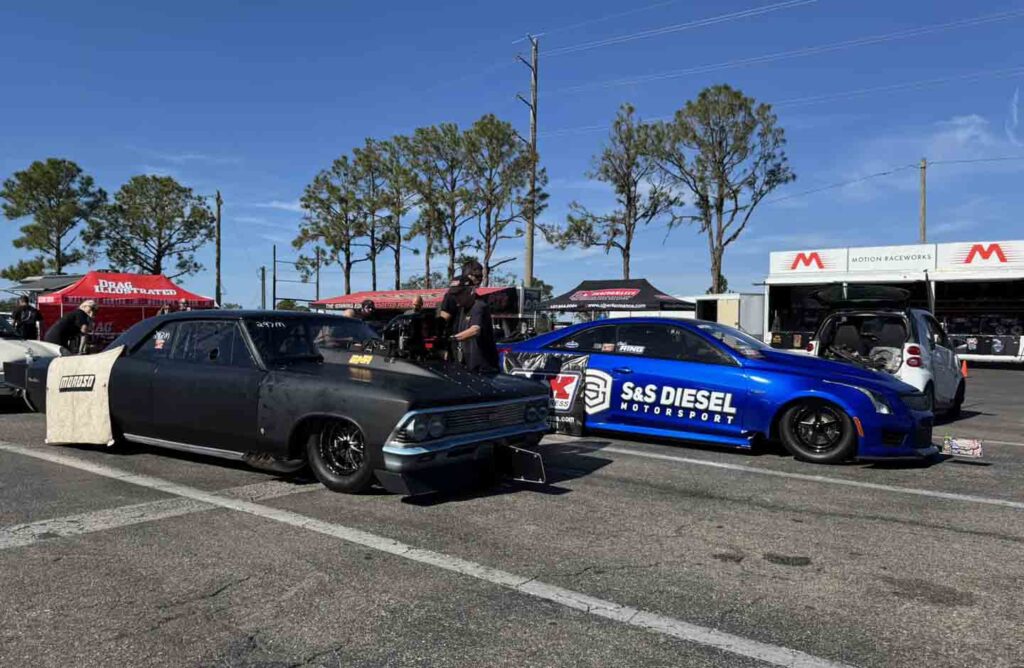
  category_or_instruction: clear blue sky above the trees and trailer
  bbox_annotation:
[0,0,1024,305]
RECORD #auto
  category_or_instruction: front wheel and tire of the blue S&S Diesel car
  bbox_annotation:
[778,400,857,464]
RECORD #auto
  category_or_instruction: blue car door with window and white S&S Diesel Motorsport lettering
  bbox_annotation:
[591,323,749,445]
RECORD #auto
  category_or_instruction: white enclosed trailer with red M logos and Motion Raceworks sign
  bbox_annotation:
[764,241,1024,363]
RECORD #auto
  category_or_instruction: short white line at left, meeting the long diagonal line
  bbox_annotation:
[0,481,323,550]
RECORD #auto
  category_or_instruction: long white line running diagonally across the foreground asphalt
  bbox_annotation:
[0,442,844,668]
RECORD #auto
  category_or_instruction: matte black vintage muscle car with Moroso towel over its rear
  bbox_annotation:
[12,310,548,494]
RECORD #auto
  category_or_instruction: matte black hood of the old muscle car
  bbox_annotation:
[279,356,548,409]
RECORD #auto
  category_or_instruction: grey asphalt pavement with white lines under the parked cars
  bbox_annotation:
[0,368,1024,667]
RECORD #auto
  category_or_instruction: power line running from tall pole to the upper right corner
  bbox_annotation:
[551,9,1024,94]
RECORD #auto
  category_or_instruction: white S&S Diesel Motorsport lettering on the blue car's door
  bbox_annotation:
[618,382,736,424]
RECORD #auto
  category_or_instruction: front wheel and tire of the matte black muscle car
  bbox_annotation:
[306,420,374,494]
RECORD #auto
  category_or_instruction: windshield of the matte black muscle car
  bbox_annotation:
[245,314,380,364]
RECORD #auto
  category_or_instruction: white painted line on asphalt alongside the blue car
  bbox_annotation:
[544,436,1024,510]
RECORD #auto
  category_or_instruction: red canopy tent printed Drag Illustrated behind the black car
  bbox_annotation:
[38,272,216,342]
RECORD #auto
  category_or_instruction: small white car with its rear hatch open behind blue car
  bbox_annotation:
[807,286,967,417]
